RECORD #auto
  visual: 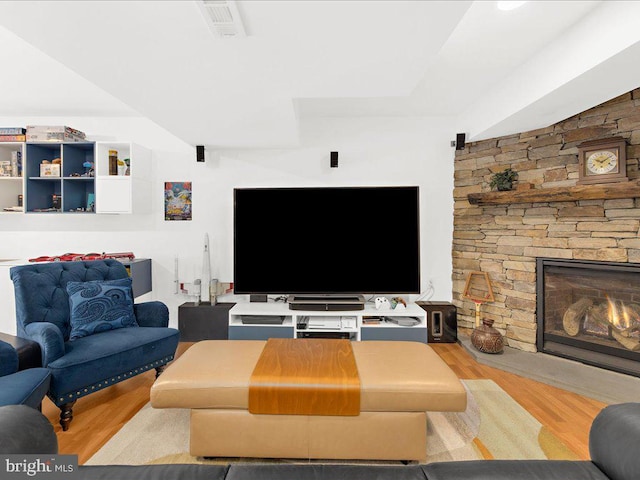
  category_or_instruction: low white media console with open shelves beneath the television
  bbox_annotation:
[229,303,427,343]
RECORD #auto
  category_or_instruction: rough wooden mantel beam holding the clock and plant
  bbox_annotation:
[467,181,640,206]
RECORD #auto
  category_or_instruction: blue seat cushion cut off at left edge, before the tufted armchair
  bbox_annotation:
[0,368,51,408]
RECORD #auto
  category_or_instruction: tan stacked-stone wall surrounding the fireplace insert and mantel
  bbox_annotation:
[452,89,640,351]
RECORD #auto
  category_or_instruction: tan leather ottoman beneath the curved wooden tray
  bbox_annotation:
[151,340,467,461]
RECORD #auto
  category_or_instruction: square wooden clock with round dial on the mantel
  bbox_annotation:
[578,137,629,185]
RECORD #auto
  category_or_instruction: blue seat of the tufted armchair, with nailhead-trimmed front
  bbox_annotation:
[48,327,180,405]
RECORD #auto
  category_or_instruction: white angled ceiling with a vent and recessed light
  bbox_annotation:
[0,0,640,147]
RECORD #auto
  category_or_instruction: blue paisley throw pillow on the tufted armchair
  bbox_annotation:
[67,278,138,340]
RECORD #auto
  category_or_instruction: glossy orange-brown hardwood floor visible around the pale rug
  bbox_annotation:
[42,343,605,464]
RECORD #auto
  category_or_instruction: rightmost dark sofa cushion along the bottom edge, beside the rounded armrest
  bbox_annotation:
[422,460,608,480]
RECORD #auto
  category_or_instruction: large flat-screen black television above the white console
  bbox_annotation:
[234,187,420,294]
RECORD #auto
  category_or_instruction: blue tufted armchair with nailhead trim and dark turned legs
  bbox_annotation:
[10,259,179,430]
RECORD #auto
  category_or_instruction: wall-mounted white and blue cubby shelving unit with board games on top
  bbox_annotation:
[0,142,152,215]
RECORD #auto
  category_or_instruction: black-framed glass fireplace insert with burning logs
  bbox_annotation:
[536,258,640,377]
